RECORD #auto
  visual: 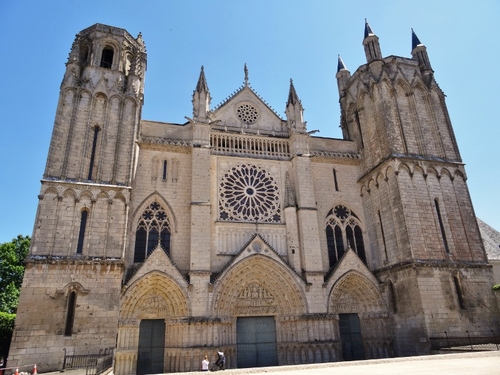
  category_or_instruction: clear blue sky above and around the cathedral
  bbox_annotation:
[0,0,500,243]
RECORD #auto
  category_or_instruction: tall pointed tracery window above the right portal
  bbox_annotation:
[325,205,366,268]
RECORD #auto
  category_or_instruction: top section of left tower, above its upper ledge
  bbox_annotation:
[44,24,146,186]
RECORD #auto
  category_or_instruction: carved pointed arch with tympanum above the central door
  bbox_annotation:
[212,254,307,318]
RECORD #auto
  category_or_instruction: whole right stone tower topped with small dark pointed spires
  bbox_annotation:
[336,23,497,355]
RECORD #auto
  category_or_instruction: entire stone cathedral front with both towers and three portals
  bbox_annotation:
[9,24,498,375]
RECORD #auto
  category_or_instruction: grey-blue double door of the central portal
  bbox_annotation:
[236,316,278,368]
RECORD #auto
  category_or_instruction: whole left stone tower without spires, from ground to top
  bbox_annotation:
[9,24,146,374]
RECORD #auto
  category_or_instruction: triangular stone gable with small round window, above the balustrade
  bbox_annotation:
[211,86,286,133]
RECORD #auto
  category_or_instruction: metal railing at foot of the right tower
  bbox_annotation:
[429,330,500,350]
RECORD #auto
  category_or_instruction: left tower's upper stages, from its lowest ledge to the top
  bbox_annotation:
[31,24,146,258]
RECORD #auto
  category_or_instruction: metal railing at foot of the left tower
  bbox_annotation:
[62,348,114,375]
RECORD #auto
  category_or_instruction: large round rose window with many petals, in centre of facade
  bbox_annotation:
[219,164,281,223]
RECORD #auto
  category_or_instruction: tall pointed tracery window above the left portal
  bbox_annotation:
[134,200,171,263]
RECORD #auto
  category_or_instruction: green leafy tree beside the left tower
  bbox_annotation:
[0,235,31,314]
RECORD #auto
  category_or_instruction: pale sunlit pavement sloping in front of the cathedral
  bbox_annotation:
[171,351,500,375]
